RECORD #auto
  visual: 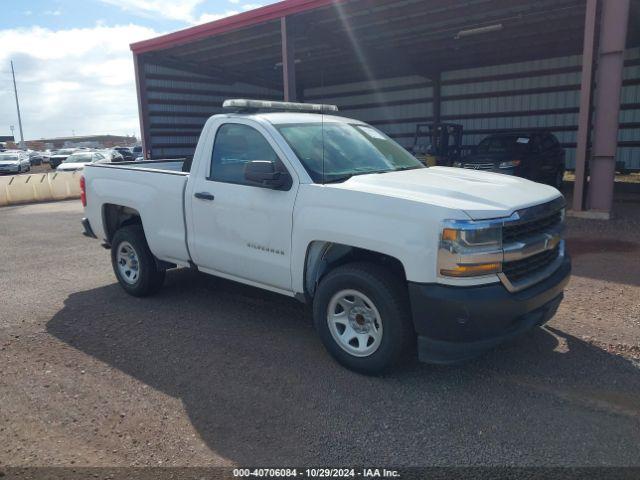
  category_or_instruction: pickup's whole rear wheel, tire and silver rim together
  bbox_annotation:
[111,225,165,297]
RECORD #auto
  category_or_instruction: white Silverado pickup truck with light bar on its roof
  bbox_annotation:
[81,100,571,373]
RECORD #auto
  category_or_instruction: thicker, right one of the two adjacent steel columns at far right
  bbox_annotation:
[589,0,630,215]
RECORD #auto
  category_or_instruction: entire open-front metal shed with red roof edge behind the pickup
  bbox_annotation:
[131,0,640,215]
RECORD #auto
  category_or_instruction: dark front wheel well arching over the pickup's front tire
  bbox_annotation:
[304,241,407,300]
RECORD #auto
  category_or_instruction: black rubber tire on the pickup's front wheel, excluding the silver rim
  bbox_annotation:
[313,262,415,375]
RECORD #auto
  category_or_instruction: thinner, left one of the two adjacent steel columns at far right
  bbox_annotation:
[573,0,598,211]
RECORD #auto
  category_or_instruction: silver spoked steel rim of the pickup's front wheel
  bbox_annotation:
[327,290,382,357]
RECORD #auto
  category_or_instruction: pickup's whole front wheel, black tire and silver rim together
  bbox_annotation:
[313,263,415,374]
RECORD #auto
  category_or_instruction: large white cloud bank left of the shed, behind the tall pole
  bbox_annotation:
[0,25,159,140]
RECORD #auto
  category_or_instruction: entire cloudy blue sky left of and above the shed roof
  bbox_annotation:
[0,0,275,140]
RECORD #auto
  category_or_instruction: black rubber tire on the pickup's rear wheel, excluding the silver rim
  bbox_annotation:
[111,225,165,297]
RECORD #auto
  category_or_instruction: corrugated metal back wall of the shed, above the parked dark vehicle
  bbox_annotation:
[305,49,640,169]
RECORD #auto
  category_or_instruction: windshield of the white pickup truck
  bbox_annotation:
[275,122,424,183]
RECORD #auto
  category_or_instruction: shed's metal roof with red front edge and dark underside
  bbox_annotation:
[132,0,585,89]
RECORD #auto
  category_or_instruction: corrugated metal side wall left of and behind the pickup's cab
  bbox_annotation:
[144,63,282,158]
